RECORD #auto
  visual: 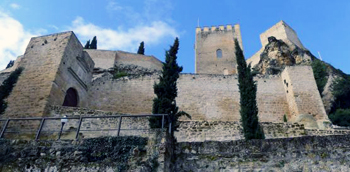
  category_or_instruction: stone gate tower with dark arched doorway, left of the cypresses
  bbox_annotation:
[1,31,94,118]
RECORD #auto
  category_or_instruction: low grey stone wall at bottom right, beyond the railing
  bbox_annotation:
[175,135,350,171]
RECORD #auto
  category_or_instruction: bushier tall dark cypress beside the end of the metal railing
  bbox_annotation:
[150,38,190,133]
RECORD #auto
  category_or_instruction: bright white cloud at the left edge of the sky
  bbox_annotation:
[0,11,40,70]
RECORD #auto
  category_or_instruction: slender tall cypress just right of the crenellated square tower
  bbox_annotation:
[235,39,264,140]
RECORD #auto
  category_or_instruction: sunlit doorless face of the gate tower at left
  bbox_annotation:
[1,32,72,118]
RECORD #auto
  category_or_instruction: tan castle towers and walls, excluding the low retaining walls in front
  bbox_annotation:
[0,21,330,129]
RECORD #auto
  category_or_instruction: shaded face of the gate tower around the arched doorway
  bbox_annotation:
[48,34,94,107]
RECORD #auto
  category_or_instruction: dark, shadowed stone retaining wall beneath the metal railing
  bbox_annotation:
[0,135,165,172]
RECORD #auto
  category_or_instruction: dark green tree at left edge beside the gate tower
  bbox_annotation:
[0,68,23,114]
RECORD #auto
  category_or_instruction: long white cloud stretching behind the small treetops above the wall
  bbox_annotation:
[70,17,178,51]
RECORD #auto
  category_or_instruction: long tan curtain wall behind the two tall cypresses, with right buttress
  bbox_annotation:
[89,66,324,125]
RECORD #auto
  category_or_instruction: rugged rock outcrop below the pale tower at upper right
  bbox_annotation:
[253,37,312,75]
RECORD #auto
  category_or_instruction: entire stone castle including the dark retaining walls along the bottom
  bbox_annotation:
[0,21,350,171]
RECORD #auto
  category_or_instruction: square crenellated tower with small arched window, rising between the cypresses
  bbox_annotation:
[195,24,243,75]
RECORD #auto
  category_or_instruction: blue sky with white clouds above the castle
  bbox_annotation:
[0,0,350,74]
